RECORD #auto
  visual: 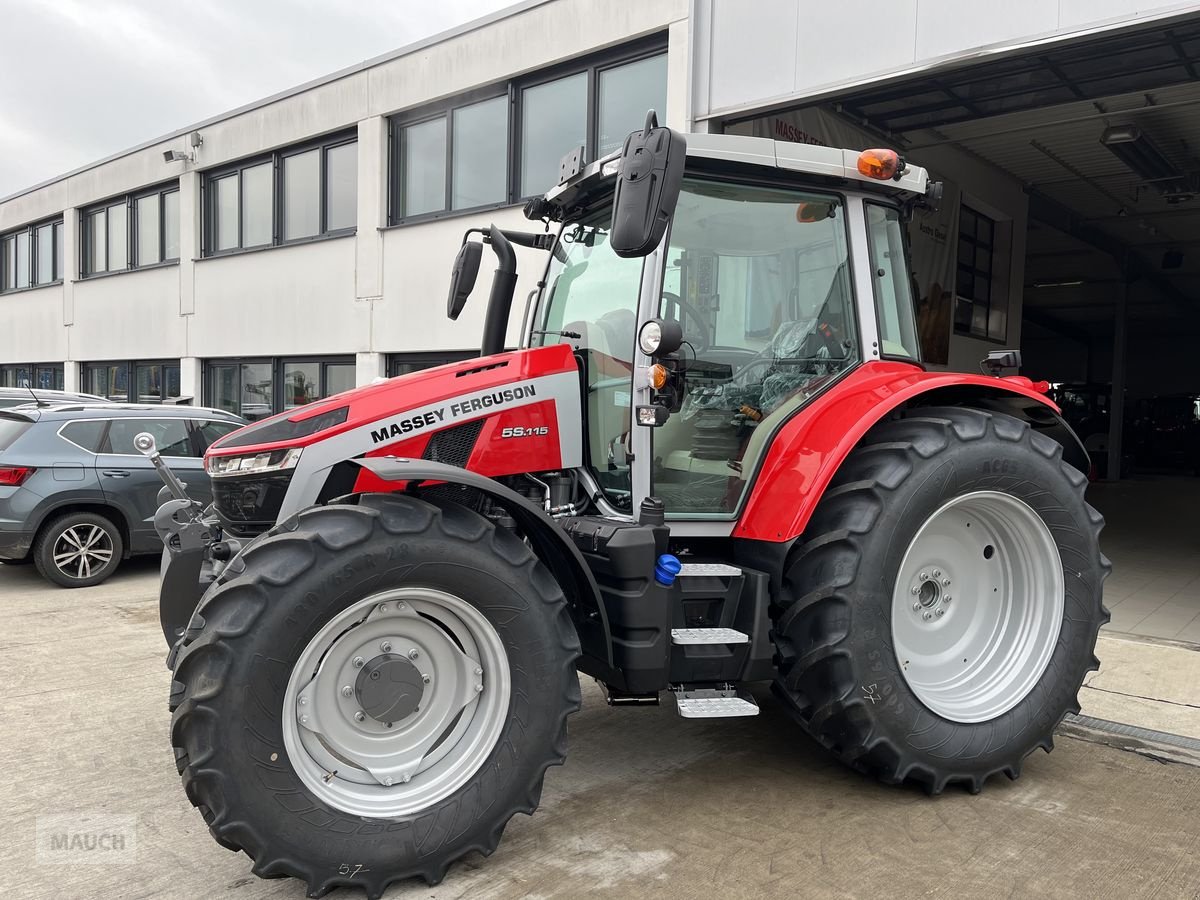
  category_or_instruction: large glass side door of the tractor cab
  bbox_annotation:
[650,178,859,518]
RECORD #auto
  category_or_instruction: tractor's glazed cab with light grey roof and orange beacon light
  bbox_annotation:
[460,127,937,521]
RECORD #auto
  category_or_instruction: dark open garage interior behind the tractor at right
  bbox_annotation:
[739,14,1200,643]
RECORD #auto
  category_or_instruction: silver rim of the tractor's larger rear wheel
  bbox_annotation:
[892,491,1064,722]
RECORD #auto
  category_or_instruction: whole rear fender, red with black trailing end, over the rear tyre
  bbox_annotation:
[733,362,1088,542]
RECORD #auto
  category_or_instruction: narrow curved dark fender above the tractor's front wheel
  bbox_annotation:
[352,457,612,666]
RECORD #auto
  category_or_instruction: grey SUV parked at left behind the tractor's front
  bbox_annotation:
[0,403,245,588]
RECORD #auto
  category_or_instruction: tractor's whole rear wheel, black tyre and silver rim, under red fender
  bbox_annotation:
[774,408,1111,793]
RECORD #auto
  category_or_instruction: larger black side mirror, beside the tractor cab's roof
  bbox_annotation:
[608,109,688,257]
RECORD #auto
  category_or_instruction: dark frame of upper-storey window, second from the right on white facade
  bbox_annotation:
[200,127,361,259]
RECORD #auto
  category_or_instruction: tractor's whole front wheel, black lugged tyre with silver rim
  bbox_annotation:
[170,494,580,898]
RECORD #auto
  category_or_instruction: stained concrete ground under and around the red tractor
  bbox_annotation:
[7,560,1200,900]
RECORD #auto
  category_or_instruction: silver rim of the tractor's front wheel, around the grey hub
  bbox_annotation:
[283,588,511,817]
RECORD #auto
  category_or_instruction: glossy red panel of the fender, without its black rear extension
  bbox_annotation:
[733,362,1060,542]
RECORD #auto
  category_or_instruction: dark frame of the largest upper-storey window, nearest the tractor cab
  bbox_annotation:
[385,32,667,228]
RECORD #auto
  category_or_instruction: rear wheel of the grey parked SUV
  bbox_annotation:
[32,512,125,588]
